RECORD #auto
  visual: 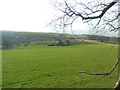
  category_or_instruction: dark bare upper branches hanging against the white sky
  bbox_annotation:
[51,0,120,32]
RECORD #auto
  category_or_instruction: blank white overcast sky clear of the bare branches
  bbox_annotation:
[0,0,118,34]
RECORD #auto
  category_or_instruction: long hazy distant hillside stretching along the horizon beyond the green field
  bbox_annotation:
[0,31,120,47]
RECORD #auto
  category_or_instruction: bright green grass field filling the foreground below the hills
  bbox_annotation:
[2,41,118,88]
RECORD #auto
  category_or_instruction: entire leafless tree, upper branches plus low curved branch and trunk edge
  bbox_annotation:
[50,0,120,88]
